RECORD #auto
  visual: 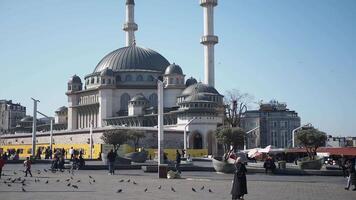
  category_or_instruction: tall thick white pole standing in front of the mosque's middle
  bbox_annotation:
[157,80,164,177]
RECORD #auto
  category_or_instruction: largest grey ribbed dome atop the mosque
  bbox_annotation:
[94,45,169,73]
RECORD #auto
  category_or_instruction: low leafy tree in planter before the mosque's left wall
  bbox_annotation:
[101,130,129,151]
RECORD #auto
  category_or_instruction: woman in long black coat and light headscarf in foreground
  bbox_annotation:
[231,157,247,200]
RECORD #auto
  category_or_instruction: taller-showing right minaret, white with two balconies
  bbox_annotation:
[200,0,218,87]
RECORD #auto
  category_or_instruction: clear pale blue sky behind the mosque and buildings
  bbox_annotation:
[0,0,356,136]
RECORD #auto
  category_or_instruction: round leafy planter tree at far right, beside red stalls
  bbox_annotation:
[297,128,327,160]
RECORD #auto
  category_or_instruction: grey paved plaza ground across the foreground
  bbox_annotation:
[0,164,356,200]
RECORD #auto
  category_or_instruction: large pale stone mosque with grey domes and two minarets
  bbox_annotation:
[0,0,224,155]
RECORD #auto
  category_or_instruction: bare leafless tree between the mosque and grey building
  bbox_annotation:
[224,89,253,127]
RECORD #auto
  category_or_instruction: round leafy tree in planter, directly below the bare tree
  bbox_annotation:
[215,127,246,160]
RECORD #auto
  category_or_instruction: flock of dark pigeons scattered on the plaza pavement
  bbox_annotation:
[2,169,213,193]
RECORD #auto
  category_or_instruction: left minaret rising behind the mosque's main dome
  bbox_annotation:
[122,0,138,46]
